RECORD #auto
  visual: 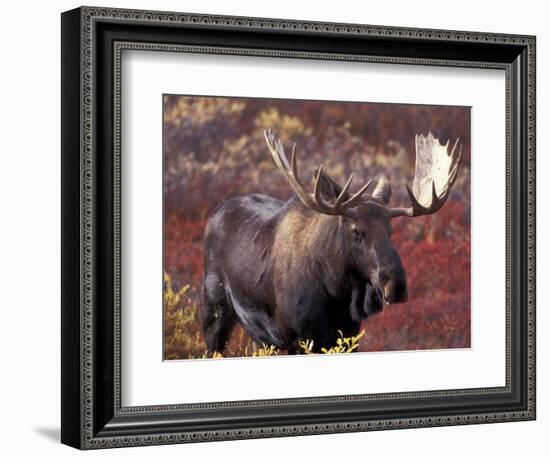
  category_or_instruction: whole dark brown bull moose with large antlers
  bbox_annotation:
[202,130,462,354]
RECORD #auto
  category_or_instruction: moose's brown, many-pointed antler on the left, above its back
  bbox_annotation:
[264,129,372,216]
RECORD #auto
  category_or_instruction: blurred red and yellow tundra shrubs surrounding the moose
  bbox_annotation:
[163,95,470,359]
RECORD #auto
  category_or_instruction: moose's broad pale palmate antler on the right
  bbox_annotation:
[390,132,462,217]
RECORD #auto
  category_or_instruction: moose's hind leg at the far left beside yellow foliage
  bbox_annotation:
[202,274,236,354]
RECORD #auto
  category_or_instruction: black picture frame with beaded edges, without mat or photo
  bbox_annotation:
[61,7,535,449]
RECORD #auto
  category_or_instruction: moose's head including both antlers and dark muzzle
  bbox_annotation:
[264,130,462,314]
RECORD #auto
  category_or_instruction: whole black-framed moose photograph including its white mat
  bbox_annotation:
[61,7,535,449]
